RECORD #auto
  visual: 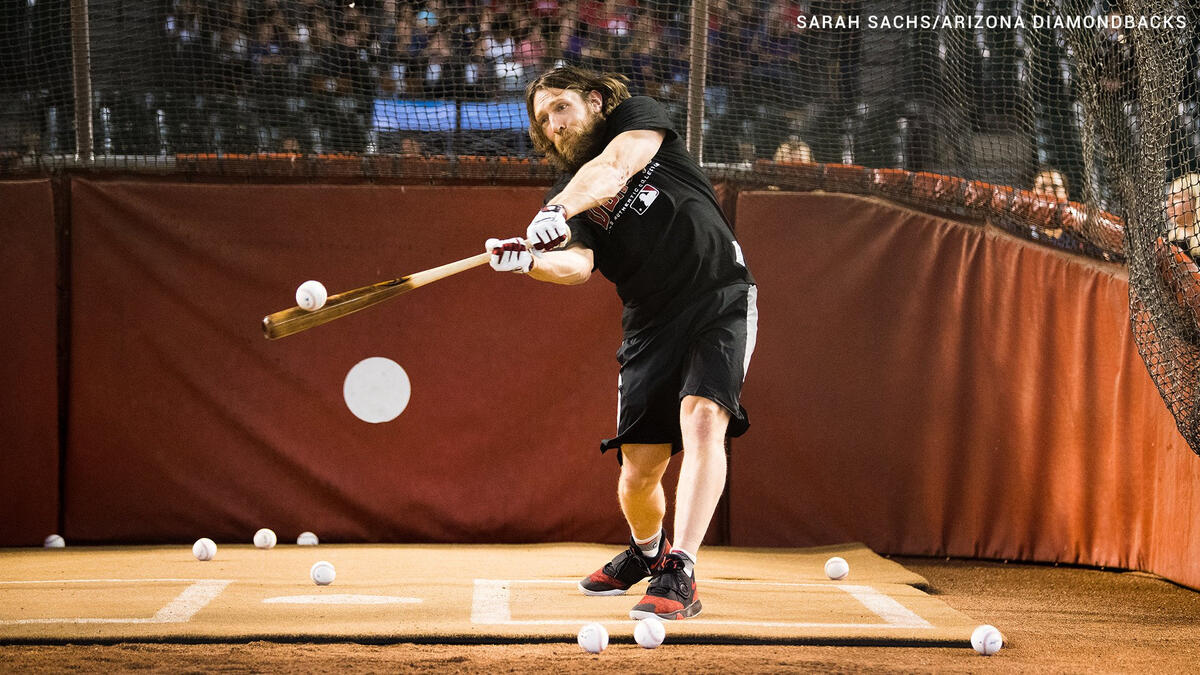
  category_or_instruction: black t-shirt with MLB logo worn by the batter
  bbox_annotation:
[546,96,754,334]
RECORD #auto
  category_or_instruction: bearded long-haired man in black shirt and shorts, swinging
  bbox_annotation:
[485,67,758,620]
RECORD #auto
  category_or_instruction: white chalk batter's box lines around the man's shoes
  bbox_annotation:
[470,579,934,629]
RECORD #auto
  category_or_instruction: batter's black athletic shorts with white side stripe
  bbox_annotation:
[600,283,758,459]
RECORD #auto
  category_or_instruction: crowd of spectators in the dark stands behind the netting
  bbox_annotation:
[7,0,1200,208]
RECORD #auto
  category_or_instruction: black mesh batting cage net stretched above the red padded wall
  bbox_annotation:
[7,0,1200,449]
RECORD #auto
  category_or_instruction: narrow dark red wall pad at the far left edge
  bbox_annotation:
[0,180,59,546]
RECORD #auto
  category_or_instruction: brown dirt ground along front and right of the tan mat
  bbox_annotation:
[0,558,1200,673]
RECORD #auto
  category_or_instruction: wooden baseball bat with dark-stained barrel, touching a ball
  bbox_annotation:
[263,252,491,340]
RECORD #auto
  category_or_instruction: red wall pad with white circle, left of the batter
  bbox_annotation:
[65,180,626,542]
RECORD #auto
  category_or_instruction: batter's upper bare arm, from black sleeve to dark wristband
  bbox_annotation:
[547,129,666,219]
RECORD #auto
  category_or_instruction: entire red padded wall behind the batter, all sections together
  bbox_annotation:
[21,180,1200,586]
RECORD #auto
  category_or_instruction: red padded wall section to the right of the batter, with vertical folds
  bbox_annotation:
[731,192,1200,585]
